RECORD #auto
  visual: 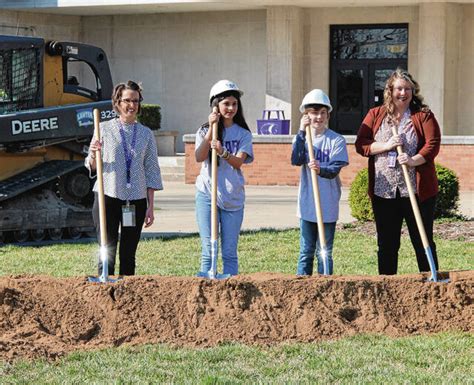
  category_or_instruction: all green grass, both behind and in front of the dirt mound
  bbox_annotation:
[0,225,474,384]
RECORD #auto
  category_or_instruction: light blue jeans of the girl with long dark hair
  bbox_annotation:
[196,191,244,275]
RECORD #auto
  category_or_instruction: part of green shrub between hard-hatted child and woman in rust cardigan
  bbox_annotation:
[349,168,374,222]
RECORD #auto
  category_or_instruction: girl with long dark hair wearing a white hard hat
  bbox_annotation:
[195,80,253,275]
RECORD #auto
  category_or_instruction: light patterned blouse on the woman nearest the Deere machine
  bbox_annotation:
[85,119,163,200]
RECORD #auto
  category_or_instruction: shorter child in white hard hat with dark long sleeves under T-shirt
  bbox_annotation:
[291,89,349,275]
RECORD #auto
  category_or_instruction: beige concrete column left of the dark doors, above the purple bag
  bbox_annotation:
[265,7,304,132]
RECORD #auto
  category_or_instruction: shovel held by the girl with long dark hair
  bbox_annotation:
[197,107,230,279]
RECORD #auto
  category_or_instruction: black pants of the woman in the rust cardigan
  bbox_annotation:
[372,191,438,275]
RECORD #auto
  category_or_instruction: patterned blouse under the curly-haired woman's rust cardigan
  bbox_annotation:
[374,110,418,199]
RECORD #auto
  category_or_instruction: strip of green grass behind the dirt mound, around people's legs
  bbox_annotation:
[0,225,474,277]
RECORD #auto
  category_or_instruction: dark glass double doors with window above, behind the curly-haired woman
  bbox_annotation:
[329,24,408,135]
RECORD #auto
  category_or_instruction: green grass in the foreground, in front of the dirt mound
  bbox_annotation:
[0,333,474,384]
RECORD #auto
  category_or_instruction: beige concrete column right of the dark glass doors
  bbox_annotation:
[417,3,448,132]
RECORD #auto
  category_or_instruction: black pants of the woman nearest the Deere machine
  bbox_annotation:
[92,194,147,275]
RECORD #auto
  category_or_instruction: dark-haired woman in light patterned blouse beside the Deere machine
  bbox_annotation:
[85,80,163,275]
